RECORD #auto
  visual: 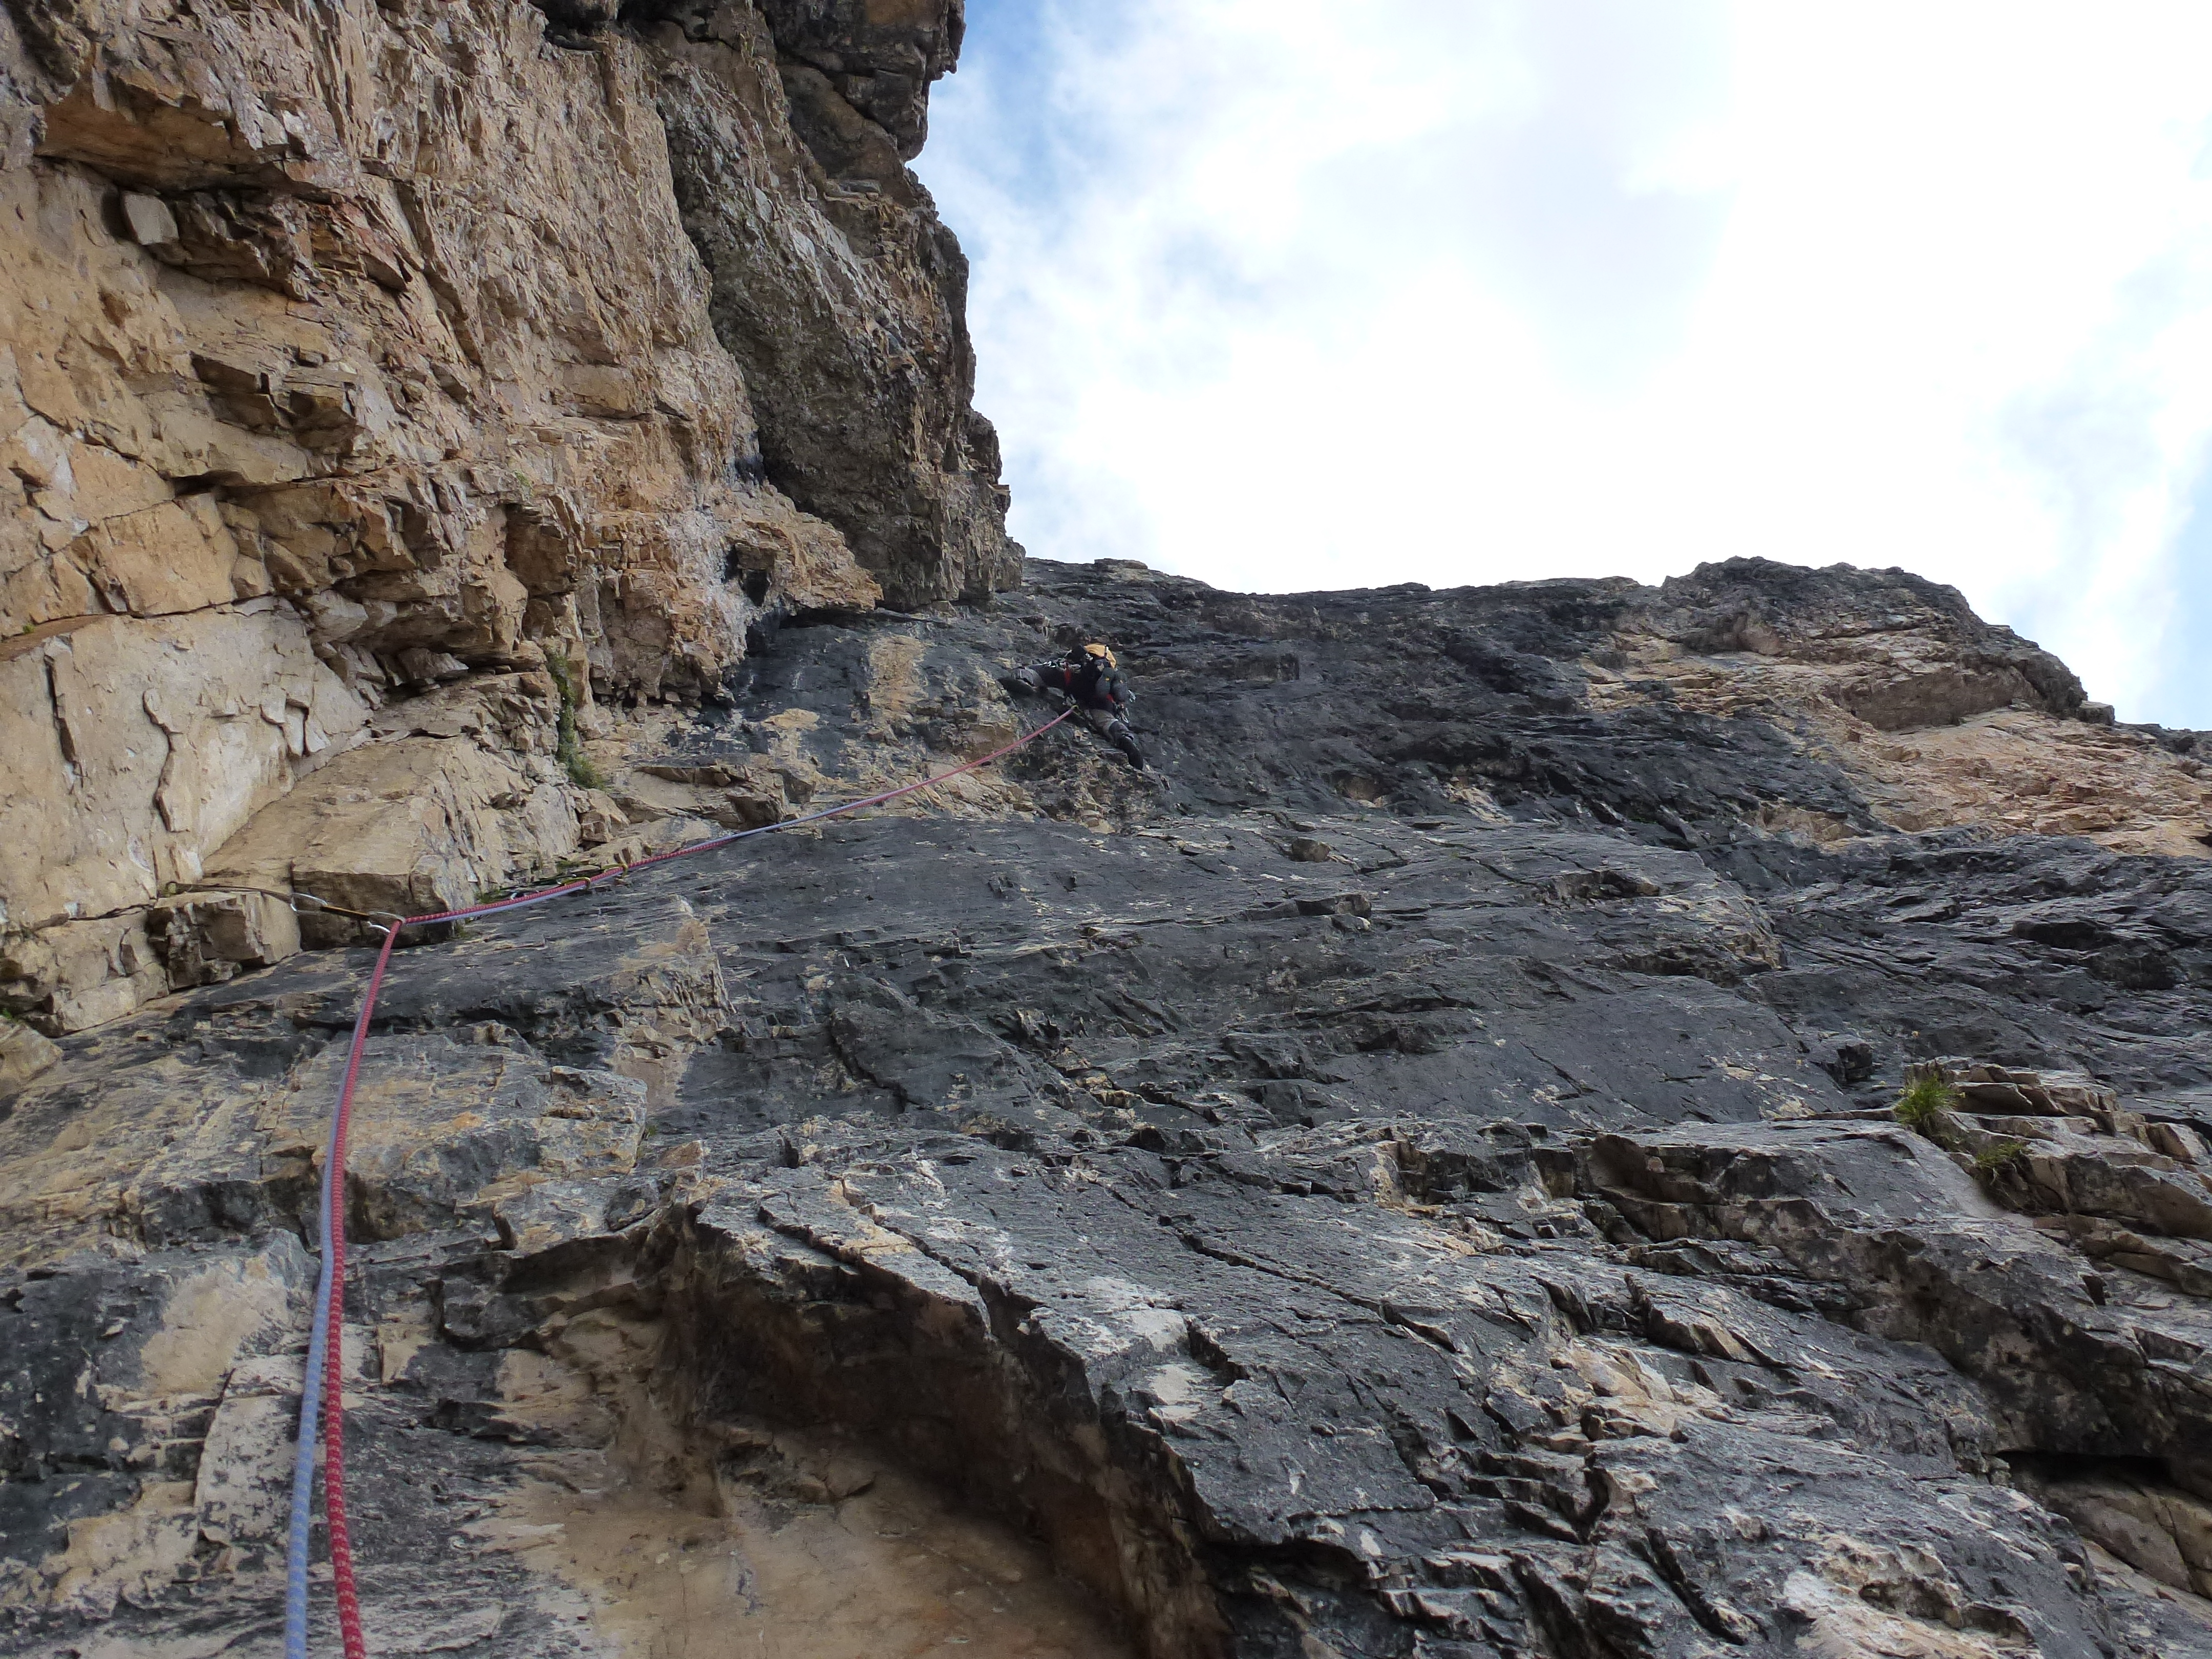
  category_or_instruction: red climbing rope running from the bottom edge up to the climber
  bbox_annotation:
[292,708,1075,1659]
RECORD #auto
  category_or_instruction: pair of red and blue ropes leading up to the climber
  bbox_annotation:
[283,708,1075,1659]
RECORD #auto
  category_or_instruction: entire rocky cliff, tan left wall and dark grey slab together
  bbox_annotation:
[0,16,2212,1659]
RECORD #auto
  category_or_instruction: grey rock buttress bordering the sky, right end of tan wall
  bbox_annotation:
[659,0,1022,606]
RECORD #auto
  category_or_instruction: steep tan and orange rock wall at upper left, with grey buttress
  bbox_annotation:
[0,0,1020,1033]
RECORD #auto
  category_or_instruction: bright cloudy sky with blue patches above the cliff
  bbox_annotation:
[916,0,2212,728]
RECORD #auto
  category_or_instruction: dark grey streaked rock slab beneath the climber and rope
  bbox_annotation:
[0,548,2212,1659]
